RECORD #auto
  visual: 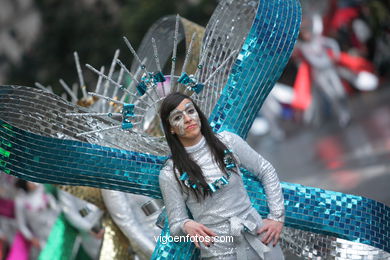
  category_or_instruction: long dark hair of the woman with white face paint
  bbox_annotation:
[160,92,238,201]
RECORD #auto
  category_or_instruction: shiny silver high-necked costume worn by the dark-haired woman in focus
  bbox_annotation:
[159,131,284,259]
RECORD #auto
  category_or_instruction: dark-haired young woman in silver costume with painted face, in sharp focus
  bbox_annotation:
[159,93,284,259]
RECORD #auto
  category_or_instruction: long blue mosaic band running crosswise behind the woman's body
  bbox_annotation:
[0,120,390,252]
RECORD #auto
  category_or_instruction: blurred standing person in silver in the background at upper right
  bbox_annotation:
[293,14,351,126]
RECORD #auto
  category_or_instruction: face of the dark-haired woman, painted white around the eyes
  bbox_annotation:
[169,98,201,143]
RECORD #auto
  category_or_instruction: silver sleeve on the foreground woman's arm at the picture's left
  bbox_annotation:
[159,162,190,236]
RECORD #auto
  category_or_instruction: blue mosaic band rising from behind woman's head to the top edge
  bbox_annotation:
[209,0,302,139]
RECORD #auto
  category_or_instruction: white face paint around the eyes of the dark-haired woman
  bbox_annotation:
[169,102,201,136]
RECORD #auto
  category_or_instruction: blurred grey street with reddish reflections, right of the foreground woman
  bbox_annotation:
[247,87,390,206]
